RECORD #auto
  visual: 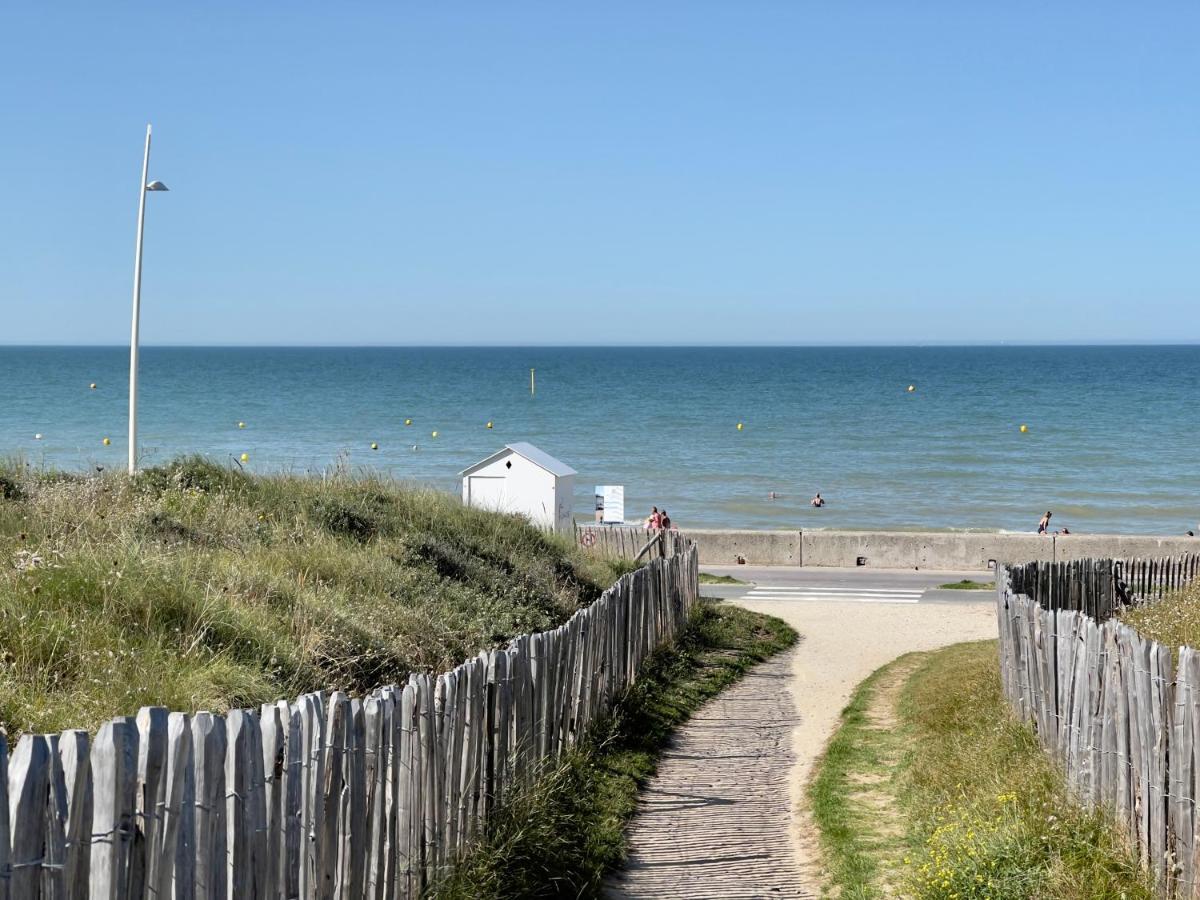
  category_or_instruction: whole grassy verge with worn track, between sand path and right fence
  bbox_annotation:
[809,641,1154,900]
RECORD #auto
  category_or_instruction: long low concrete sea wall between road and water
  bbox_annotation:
[686,529,1200,570]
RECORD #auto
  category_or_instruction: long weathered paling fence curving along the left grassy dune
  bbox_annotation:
[0,534,698,900]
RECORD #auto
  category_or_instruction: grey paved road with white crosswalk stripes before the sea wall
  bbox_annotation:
[701,565,992,604]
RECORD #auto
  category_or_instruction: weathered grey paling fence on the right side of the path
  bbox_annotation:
[996,556,1200,898]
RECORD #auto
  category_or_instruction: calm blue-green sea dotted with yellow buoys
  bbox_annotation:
[0,347,1200,534]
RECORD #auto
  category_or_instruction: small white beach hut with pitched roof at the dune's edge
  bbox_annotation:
[458,442,577,532]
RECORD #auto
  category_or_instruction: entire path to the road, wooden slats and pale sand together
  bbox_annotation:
[605,596,996,899]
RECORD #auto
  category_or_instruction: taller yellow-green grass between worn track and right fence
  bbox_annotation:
[900,641,1154,900]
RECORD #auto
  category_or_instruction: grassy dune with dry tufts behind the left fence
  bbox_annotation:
[0,457,633,734]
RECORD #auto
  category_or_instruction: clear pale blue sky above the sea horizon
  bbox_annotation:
[0,0,1200,344]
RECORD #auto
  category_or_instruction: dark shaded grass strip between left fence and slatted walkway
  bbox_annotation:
[431,601,796,900]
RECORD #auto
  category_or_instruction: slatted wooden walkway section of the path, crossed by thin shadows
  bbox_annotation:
[605,649,816,900]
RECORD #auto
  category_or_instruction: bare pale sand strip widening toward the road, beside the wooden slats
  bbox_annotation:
[739,595,996,893]
